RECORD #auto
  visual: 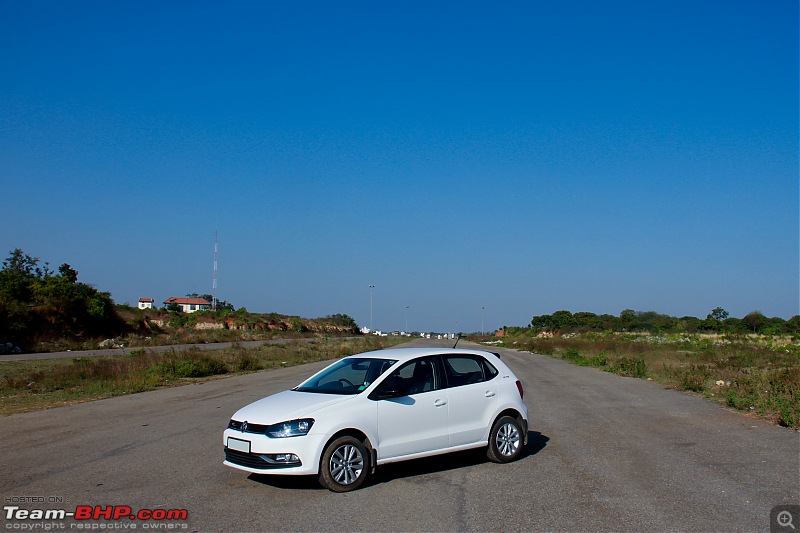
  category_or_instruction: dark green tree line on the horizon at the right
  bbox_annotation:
[531,307,800,335]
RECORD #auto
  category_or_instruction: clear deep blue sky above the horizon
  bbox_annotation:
[0,0,800,331]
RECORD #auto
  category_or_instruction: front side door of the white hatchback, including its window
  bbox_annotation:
[369,357,449,460]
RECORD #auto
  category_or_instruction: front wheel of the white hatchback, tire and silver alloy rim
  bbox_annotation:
[319,435,369,492]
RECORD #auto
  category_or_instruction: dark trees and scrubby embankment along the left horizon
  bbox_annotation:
[0,249,360,354]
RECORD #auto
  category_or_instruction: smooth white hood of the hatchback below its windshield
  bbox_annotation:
[233,390,354,425]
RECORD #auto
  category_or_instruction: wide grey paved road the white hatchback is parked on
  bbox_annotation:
[0,341,800,532]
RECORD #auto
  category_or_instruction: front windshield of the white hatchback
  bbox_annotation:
[293,358,397,394]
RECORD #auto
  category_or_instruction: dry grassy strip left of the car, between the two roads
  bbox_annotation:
[0,337,407,415]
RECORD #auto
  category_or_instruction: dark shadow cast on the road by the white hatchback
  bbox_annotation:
[248,431,550,490]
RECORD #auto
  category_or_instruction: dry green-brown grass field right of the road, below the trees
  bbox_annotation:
[503,333,800,429]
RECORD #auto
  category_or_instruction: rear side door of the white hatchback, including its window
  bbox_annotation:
[442,354,498,446]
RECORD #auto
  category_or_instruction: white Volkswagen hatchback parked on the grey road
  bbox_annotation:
[223,348,528,492]
